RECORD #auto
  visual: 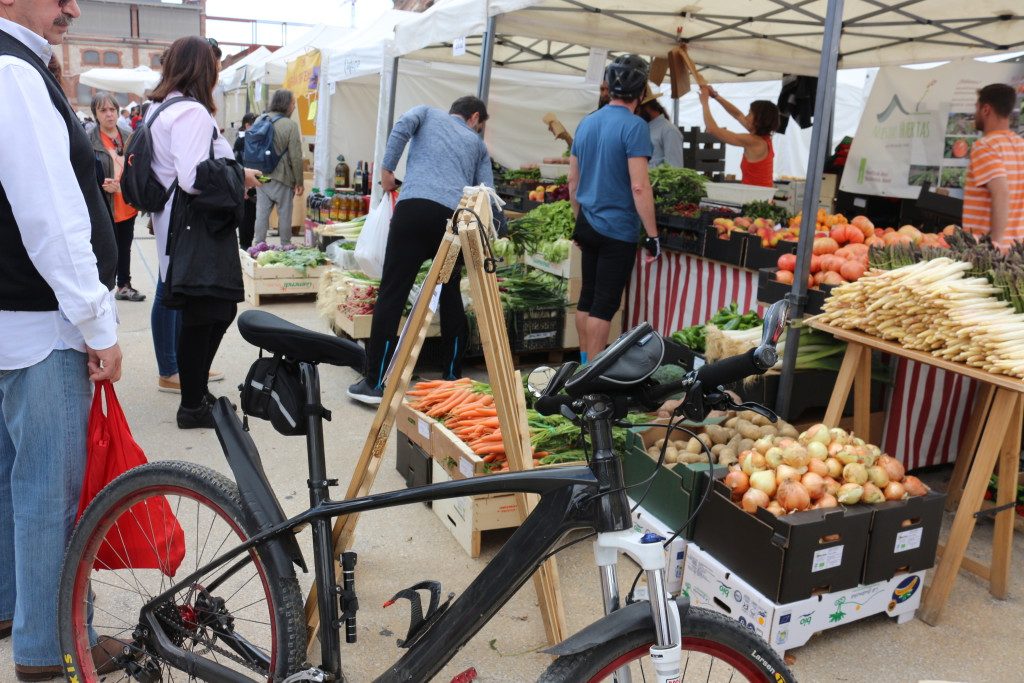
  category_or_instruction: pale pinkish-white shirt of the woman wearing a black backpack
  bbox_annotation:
[145,91,234,280]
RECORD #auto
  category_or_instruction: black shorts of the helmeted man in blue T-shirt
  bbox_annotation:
[572,210,637,321]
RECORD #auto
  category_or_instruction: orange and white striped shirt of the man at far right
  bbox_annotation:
[964,130,1024,245]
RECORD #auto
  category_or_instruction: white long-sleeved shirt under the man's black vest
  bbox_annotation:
[0,17,118,370]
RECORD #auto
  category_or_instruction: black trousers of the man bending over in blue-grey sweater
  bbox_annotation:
[364,199,469,387]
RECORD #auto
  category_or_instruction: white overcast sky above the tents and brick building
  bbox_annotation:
[206,0,391,54]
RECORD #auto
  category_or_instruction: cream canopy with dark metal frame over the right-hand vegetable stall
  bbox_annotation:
[394,0,1024,82]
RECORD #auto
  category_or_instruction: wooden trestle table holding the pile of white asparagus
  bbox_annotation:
[808,318,1024,626]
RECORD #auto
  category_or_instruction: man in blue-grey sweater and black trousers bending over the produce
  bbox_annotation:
[348,96,495,405]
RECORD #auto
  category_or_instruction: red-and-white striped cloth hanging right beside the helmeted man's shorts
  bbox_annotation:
[626,252,759,335]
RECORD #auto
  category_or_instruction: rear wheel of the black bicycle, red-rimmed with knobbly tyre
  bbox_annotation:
[58,462,306,682]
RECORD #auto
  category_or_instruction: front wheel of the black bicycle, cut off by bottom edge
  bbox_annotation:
[540,607,796,683]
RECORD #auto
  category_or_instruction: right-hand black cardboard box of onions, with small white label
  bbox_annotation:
[851,490,946,584]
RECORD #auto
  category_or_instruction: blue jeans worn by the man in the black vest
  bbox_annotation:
[0,350,92,667]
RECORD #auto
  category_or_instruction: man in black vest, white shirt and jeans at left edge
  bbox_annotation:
[0,0,121,681]
